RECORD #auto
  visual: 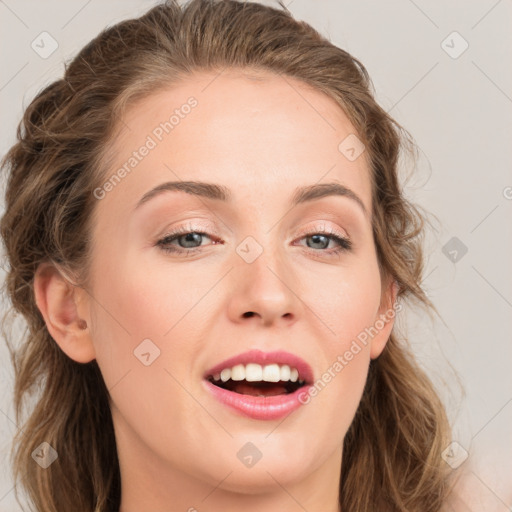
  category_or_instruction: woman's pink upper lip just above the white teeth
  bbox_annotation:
[204,350,313,384]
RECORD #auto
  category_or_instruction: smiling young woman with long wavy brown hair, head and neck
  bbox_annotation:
[1,0,458,512]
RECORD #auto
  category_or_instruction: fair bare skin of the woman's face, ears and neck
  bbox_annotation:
[35,69,396,512]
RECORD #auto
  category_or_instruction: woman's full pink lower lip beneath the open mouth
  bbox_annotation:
[203,380,307,420]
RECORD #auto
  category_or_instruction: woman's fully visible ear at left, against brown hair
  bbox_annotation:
[34,263,96,363]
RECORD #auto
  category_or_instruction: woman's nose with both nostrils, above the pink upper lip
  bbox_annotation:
[228,251,303,326]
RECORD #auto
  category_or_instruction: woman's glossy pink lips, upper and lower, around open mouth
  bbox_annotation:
[203,350,313,420]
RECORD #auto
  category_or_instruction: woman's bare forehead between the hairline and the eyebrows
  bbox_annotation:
[96,69,371,218]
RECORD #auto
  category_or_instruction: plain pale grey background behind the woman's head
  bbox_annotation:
[0,0,512,512]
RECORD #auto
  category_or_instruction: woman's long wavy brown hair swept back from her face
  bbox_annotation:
[0,0,450,512]
